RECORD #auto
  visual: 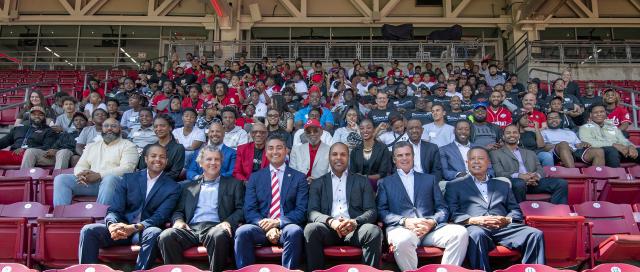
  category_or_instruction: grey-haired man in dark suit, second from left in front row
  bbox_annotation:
[158,145,244,271]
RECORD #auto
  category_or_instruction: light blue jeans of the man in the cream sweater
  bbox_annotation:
[53,174,122,207]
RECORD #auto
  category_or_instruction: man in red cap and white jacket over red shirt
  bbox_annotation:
[289,119,329,182]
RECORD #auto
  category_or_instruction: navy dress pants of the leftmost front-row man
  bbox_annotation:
[78,223,162,270]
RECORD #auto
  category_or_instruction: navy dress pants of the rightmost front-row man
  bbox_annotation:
[467,224,544,272]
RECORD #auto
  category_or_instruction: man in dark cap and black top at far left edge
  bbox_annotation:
[0,106,56,165]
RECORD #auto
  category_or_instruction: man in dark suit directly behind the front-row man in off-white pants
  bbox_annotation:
[407,119,442,182]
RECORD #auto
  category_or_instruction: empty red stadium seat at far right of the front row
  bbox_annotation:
[573,201,640,267]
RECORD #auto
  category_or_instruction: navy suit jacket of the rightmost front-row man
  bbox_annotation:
[444,177,523,224]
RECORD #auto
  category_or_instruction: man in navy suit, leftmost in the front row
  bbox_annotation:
[78,144,180,270]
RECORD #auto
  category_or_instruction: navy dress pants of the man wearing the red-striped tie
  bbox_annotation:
[234,224,304,269]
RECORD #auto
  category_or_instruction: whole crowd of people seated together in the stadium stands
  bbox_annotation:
[0,54,640,271]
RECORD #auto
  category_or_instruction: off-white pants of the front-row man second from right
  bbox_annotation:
[387,224,469,271]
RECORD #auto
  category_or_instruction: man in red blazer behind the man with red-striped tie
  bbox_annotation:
[233,122,269,181]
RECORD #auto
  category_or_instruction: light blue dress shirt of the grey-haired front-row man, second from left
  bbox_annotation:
[189,176,220,224]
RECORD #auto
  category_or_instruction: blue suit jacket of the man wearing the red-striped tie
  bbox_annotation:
[244,166,309,228]
